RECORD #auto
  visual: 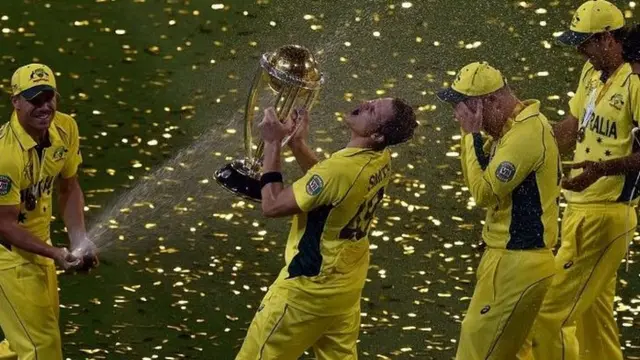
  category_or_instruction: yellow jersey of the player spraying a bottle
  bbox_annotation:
[0,112,82,269]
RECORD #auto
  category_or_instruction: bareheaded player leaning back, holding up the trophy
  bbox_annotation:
[236,98,417,360]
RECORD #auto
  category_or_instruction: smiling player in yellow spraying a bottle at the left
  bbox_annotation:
[0,64,97,360]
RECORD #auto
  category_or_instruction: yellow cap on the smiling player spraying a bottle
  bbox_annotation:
[11,64,56,100]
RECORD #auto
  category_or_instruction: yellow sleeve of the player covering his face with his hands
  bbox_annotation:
[461,119,544,207]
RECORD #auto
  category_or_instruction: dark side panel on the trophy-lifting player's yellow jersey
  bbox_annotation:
[287,205,333,279]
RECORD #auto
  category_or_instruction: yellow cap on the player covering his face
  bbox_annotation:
[436,62,507,104]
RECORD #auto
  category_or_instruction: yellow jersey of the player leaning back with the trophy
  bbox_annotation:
[272,148,391,315]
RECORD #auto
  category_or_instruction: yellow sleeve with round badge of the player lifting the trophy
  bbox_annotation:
[292,158,350,212]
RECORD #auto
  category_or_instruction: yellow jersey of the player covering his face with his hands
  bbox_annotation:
[461,100,562,250]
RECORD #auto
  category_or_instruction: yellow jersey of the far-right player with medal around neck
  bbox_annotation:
[565,62,640,204]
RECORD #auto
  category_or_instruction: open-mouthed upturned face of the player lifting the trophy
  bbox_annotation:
[346,98,393,137]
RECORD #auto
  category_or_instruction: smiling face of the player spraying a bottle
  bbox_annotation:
[13,91,57,131]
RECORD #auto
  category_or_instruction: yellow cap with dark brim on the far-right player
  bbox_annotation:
[558,0,624,46]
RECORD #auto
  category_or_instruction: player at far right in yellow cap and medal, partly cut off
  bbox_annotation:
[532,0,640,360]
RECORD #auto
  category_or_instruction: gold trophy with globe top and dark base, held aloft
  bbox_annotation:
[214,45,324,202]
